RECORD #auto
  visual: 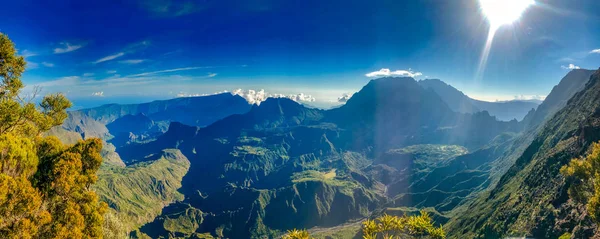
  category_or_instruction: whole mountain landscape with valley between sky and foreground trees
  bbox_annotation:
[50,70,600,238]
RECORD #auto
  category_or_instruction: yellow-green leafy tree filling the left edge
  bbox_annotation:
[0,33,107,238]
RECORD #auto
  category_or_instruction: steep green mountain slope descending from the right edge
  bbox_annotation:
[448,68,600,238]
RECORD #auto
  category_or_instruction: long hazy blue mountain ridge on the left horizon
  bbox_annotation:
[56,93,252,151]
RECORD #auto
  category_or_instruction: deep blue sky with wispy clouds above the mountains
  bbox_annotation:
[0,0,600,107]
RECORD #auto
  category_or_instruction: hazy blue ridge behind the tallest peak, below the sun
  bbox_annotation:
[419,79,539,121]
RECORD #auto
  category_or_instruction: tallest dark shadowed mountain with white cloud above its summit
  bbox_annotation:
[325,78,519,152]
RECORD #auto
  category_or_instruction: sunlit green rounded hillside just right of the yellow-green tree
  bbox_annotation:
[94,150,190,232]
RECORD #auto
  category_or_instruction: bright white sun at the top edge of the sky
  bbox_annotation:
[479,0,534,28]
